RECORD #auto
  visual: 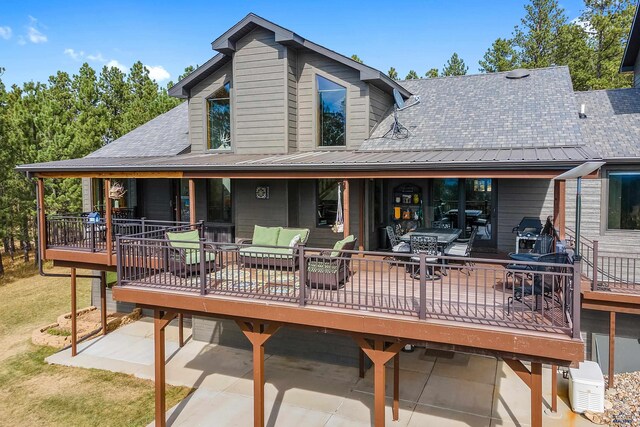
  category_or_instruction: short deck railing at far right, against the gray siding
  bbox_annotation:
[567,230,640,294]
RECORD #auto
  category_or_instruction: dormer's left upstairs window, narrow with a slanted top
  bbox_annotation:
[207,83,231,150]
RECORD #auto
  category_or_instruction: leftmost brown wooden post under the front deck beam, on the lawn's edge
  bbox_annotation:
[153,309,176,427]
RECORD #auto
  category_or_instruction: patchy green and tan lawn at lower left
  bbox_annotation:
[0,262,190,426]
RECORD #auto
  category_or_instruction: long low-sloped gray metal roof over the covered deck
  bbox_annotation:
[18,147,593,172]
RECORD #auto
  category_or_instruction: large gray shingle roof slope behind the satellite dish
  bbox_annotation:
[362,67,581,150]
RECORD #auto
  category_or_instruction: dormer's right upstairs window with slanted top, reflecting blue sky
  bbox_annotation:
[316,76,347,147]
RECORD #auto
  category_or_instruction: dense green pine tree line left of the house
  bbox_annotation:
[0,62,193,274]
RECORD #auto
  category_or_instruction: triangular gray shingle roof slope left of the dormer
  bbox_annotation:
[87,102,190,158]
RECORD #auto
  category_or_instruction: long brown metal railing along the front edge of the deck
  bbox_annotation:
[116,235,580,337]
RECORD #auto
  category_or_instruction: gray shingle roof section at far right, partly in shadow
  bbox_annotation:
[575,88,640,159]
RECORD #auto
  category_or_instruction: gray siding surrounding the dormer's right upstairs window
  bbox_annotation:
[298,52,370,151]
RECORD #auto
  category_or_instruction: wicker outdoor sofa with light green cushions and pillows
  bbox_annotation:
[238,225,309,270]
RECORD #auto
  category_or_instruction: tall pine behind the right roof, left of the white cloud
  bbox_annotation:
[513,0,567,68]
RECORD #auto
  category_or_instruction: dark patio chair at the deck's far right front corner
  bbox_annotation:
[507,253,569,313]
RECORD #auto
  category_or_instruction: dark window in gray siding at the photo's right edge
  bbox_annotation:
[607,172,640,230]
